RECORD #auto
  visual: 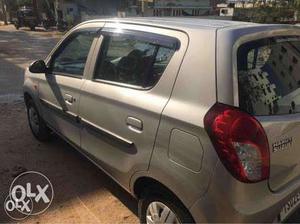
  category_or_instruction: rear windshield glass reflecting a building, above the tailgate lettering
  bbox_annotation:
[237,36,300,116]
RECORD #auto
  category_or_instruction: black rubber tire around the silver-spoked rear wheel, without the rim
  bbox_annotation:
[138,187,195,224]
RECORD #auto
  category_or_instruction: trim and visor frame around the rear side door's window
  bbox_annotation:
[91,27,181,91]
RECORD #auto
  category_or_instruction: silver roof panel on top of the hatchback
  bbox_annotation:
[84,17,255,30]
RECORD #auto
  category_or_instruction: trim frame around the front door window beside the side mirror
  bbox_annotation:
[47,27,101,79]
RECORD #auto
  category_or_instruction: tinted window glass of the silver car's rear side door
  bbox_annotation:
[94,29,177,88]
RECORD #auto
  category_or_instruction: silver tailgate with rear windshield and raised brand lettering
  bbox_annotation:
[237,35,300,191]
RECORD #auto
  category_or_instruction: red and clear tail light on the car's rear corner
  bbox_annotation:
[204,103,270,183]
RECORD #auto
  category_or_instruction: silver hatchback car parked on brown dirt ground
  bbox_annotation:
[24,18,300,224]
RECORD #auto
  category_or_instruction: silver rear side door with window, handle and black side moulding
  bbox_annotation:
[79,23,187,186]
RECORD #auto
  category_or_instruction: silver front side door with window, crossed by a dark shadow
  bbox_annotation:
[39,30,95,146]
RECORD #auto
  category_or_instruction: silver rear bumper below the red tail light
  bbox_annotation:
[190,162,300,223]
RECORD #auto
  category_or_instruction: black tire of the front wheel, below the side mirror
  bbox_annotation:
[26,99,51,142]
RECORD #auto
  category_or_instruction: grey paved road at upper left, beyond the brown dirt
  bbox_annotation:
[0,26,60,102]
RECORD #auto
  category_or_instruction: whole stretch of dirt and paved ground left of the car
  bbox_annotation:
[0,26,138,223]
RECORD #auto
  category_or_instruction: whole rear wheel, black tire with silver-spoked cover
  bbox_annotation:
[139,191,194,224]
